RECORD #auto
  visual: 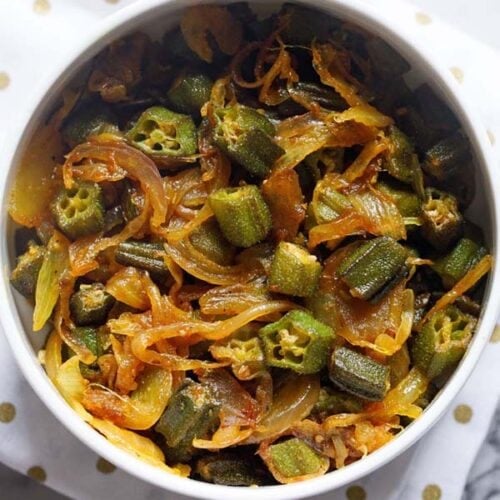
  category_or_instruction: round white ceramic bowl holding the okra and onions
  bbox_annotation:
[0,0,500,500]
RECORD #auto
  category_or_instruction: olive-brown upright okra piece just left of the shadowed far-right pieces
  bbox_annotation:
[382,126,420,184]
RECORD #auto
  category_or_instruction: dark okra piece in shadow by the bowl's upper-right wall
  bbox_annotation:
[422,132,470,181]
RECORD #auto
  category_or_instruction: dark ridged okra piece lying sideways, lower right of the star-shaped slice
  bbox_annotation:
[329,347,390,401]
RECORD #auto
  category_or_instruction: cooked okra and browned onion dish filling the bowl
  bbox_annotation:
[9,3,492,486]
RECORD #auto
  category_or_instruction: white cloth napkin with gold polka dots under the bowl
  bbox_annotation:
[0,0,500,500]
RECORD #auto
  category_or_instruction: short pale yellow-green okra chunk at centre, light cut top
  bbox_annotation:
[269,241,321,297]
